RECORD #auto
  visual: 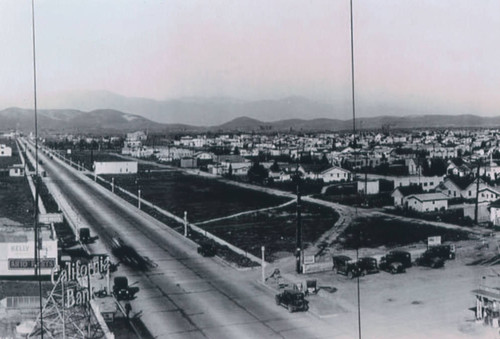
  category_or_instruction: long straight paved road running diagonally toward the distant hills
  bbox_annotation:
[26,140,357,339]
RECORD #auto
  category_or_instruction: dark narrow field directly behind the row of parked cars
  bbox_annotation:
[337,217,469,249]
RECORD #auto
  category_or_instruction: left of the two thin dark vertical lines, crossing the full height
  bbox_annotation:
[31,0,43,339]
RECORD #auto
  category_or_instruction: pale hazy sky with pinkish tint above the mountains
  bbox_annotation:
[0,0,500,116]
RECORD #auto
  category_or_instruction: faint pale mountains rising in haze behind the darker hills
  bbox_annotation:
[39,91,350,126]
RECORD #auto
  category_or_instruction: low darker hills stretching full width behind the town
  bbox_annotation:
[0,108,500,134]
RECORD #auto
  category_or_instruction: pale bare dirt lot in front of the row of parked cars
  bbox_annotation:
[282,239,500,339]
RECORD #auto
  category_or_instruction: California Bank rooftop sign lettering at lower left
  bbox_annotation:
[50,255,109,308]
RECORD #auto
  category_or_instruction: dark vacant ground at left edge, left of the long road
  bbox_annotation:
[0,177,34,225]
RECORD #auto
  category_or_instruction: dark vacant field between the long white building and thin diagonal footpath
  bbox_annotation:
[103,171,287,223]
